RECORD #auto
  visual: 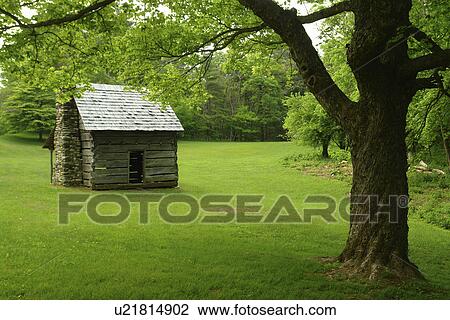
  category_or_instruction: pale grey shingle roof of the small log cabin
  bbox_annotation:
[75,84,183,131]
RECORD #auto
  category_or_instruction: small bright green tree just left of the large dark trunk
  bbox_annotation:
[284,94,344,158]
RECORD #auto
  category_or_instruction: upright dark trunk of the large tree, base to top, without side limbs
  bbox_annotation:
[339,0,422,279]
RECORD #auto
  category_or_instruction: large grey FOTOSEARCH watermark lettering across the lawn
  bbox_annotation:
[58,193,408,225]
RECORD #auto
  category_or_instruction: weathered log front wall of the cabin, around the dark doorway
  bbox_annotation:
[88,131,178,190]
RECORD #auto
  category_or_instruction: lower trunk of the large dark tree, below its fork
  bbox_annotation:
[339,97,420,279]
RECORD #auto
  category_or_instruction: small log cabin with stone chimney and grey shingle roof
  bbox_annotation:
[44,84,183,190]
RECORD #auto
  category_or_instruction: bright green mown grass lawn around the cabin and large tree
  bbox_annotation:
[0,136,450,299]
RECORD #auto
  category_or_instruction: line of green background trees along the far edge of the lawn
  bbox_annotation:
[0,4,444,165]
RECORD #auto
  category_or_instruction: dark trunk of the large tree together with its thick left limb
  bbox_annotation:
[239,0,450,279]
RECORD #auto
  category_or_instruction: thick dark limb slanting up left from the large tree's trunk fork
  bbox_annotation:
[239,0,353,127]
